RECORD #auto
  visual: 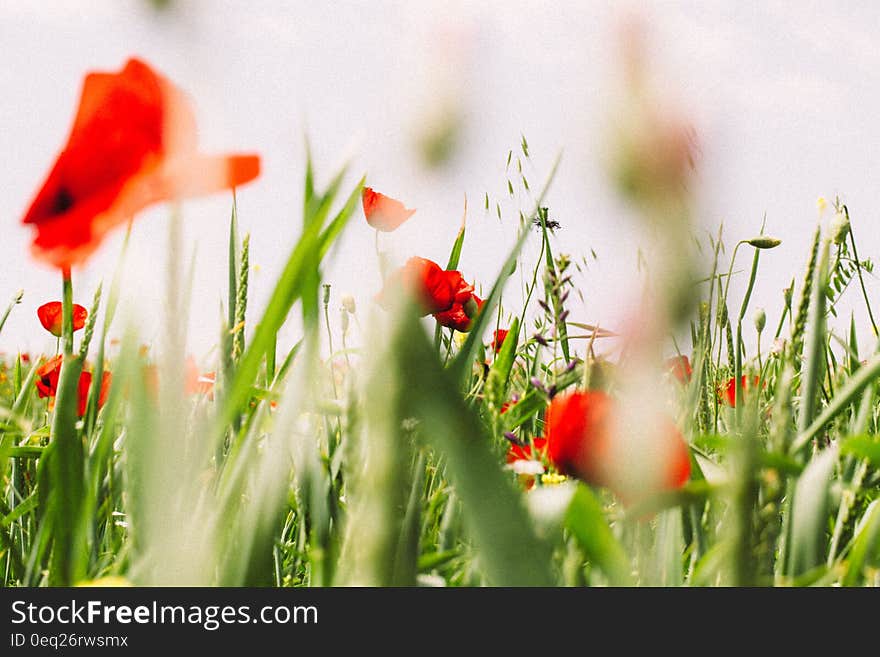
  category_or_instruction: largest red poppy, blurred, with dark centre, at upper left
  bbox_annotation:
[23,59,260,269]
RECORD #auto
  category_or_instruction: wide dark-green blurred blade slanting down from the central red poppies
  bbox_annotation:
[388,312,554,586]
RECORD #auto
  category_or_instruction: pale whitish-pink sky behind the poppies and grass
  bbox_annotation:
[0,0,880,355]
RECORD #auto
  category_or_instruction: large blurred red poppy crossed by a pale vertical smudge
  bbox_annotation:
[544,391,691,493]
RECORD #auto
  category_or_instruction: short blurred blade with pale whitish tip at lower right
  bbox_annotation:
[787,447,837,578]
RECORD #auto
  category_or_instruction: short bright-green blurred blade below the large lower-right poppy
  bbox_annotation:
[565,484,633,586]
